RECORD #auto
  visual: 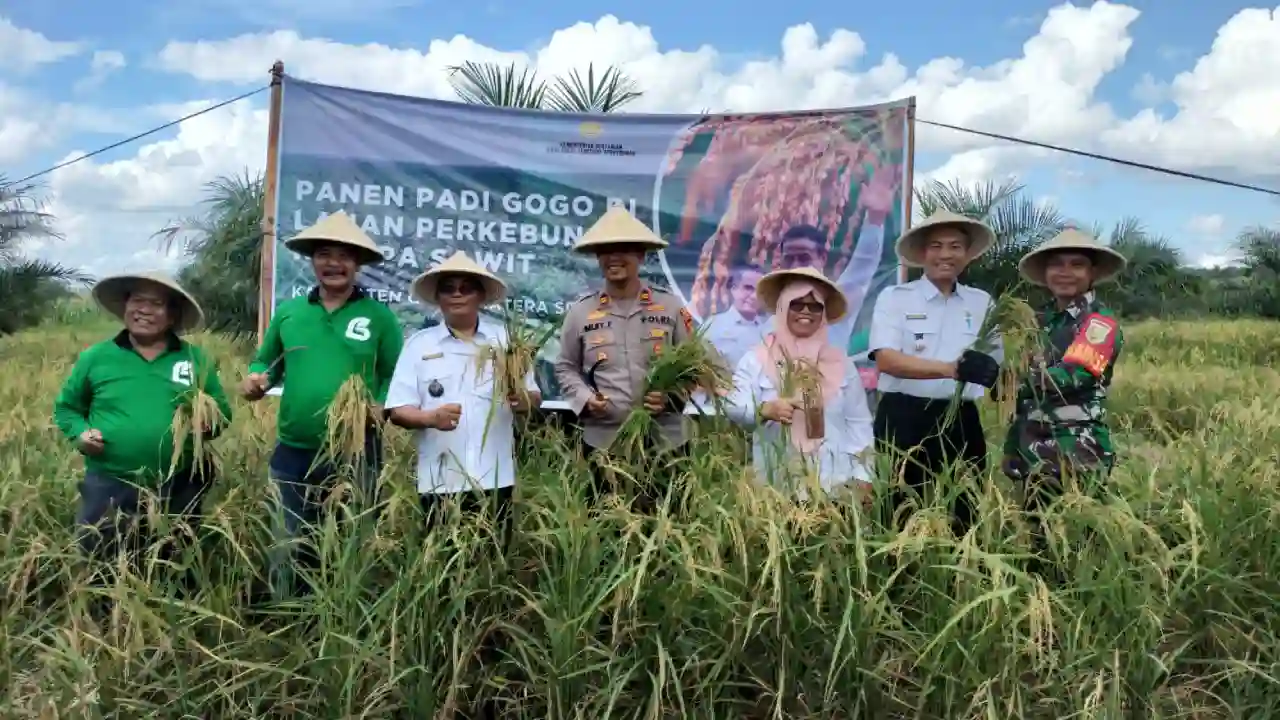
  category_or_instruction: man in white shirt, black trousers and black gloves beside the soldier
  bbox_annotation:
[869,210,1004,537]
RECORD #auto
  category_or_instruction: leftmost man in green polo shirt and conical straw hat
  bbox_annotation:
[54,273,232,584]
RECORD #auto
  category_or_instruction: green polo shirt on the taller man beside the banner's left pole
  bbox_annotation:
[248,287,404,450]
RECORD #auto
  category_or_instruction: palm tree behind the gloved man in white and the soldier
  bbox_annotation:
[915,181,1068,295]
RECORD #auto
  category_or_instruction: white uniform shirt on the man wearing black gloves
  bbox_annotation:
[868,278,1005,400]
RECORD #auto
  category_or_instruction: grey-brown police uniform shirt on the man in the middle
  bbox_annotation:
[556,287,694,448]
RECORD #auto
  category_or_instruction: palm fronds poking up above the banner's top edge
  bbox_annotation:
[449,63,644,113]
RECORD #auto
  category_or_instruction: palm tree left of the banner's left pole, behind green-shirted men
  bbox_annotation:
[154,172,264,337]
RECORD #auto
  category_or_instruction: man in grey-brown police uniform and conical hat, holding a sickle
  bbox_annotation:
[556,206,694,501]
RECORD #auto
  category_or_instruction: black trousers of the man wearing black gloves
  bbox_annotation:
[874,392,987,537]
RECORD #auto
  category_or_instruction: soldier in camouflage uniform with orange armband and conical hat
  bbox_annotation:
[1001,228,1125,545]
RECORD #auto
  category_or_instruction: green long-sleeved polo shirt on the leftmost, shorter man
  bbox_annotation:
[54,331,232,486]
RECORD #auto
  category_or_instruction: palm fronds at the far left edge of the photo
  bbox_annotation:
[0,176,90,334]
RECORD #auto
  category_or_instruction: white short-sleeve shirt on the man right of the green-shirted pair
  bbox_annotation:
[387,318,538,495]
